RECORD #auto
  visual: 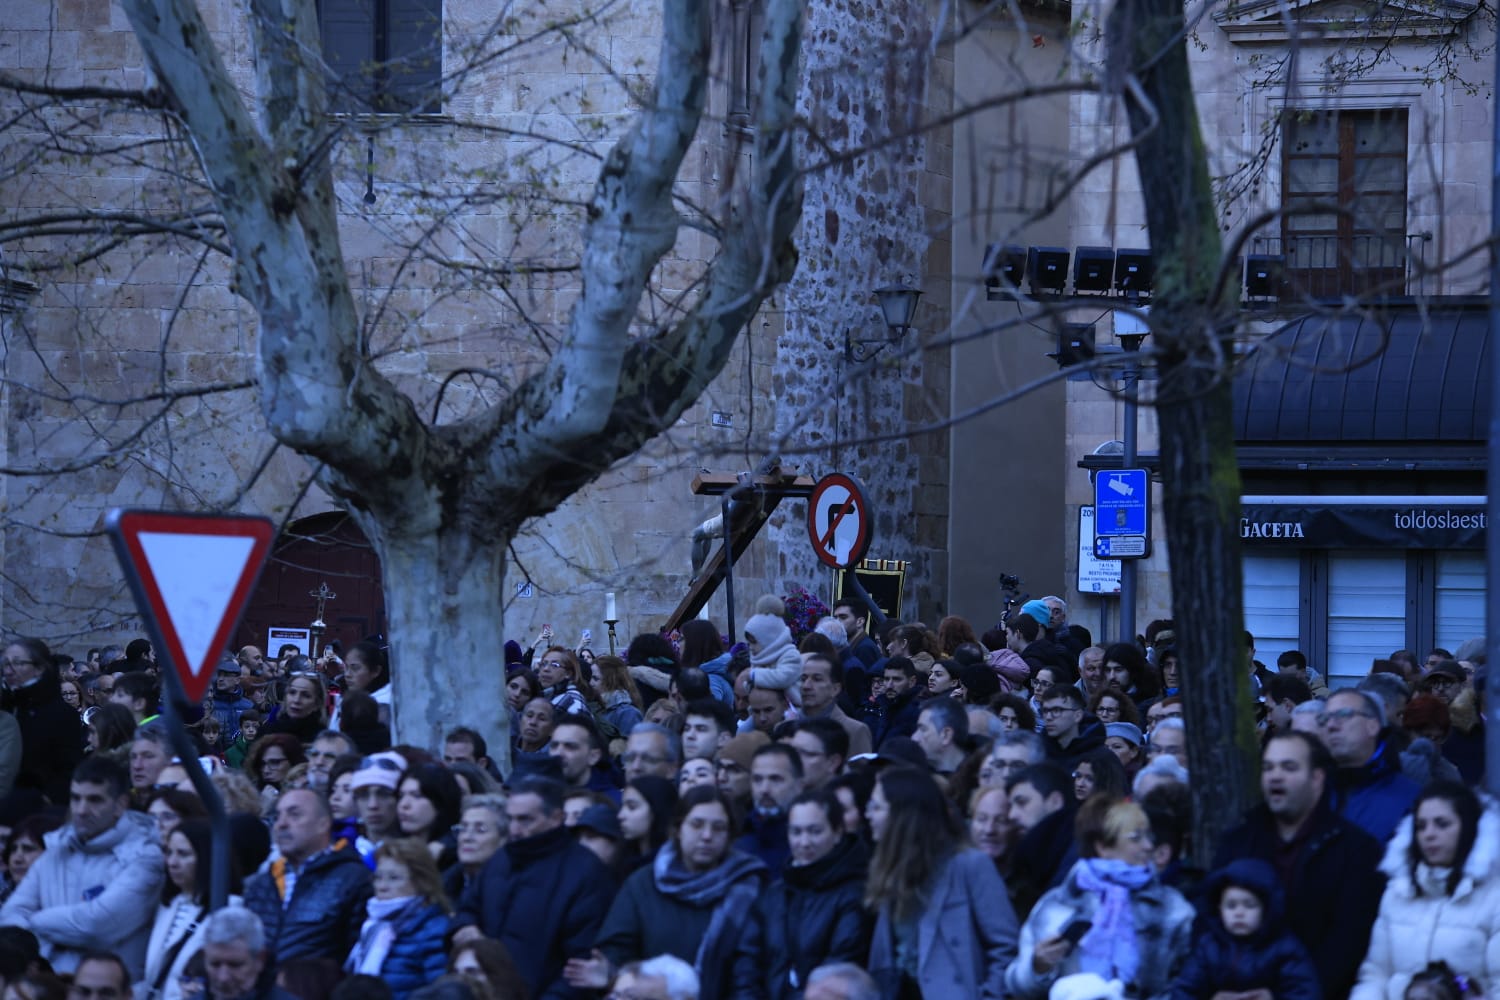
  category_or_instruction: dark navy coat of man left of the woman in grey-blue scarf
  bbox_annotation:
[453,826,617,1000]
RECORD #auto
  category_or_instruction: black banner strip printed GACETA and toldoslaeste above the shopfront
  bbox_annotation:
[1239,502,1490,549]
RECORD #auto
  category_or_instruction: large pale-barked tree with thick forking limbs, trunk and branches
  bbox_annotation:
[109,0,803,757]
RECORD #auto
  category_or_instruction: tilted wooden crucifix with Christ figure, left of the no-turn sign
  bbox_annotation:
[666,457,815,636]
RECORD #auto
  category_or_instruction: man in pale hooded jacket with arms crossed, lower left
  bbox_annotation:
[0,756,164,981]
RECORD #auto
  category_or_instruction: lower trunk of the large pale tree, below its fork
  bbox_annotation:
[360,516,510,772]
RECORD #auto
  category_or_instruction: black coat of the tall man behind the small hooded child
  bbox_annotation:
[1214,802,1386,997]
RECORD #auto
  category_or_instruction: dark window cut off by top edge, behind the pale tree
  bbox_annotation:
[318,0,443,114]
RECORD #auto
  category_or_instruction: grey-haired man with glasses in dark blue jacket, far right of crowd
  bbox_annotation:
[1319,688,1421,844]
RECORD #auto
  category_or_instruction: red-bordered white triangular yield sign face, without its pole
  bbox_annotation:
[105,510,276,702]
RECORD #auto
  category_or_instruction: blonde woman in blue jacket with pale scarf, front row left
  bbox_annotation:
[344,837,453,1000]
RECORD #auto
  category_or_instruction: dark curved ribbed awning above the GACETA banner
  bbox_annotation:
[1235,304,1491,449]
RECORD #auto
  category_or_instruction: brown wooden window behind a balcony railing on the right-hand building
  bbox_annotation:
[1281,108,1407,298]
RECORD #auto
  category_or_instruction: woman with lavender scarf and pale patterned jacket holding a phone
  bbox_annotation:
[1005,795,1194,1000]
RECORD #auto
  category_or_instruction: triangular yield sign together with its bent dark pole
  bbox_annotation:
[105,508,276,910]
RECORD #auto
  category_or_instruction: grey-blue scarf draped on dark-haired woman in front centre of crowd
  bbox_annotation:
[653,841,765,997]
